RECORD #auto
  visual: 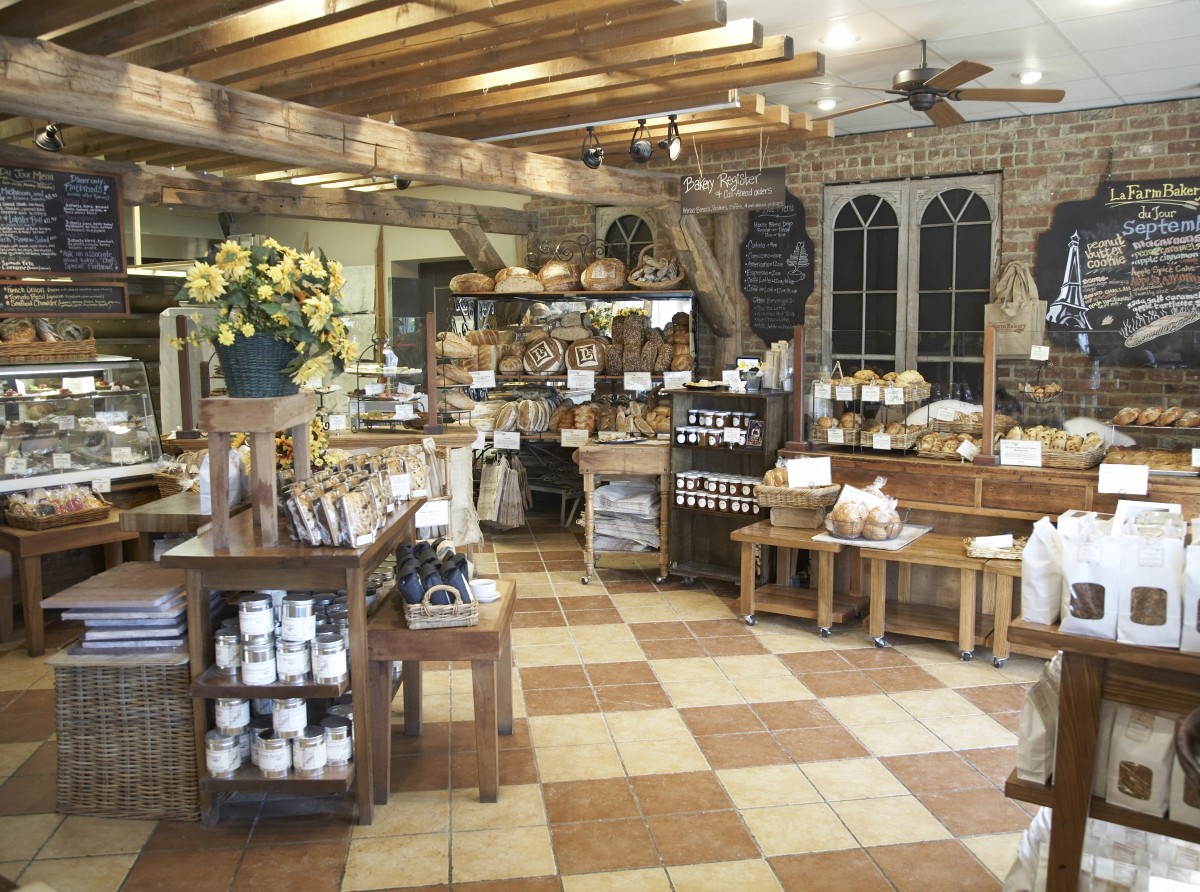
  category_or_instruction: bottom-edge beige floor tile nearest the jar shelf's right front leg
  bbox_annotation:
[342,833,450,892]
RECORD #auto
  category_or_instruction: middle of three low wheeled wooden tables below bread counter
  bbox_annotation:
[859,533,991,660]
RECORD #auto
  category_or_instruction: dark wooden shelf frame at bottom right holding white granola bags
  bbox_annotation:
[1004,619,1200,892]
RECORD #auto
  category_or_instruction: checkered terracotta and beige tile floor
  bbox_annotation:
[0,511,1040,892]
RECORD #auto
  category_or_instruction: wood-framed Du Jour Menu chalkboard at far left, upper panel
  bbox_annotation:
[0,164,125,276]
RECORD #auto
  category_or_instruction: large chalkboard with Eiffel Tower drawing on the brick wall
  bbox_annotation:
[1037,178,1200,349]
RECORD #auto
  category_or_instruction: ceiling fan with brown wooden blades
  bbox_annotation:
[814,41,1067,127]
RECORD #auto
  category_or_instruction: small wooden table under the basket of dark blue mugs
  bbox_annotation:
[364,580,517,804]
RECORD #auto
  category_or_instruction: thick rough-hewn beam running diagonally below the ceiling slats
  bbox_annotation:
[0,36,679,206]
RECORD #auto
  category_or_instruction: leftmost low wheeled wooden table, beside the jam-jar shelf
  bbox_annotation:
[730,520,866,637]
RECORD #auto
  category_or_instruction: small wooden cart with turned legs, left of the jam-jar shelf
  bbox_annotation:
[576,439,671,585]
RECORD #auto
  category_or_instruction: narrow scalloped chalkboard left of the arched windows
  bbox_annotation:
[742,192,812,343]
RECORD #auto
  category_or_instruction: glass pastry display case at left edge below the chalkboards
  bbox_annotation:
[0,357,160,492]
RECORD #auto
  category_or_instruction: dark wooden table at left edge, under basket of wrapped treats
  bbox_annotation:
[0,509,137,657]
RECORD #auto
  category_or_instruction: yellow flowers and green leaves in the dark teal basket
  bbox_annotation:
[170,239,358,384]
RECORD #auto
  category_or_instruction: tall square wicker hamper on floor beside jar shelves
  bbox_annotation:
[47,654,200,821]
